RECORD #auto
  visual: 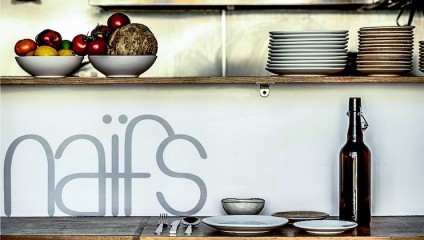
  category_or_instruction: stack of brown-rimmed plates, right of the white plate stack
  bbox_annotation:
[357,26,414,76]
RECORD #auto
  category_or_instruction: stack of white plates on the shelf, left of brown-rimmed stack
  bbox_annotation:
[265,30,349,76]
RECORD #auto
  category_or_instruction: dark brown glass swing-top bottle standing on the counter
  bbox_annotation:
[339,98,371,225]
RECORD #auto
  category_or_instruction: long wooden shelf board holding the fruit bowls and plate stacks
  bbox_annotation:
[0,76,424,85]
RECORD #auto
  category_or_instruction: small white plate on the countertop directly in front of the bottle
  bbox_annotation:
[293,220,358,234]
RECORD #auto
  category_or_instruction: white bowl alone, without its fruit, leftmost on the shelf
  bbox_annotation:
[15,56,84,78]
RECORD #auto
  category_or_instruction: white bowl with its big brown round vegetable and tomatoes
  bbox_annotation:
[88,13,158,77]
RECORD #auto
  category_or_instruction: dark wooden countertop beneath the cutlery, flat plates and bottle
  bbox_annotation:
[1,216,424,240]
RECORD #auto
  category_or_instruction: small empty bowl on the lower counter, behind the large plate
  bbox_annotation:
[221,198,265,215]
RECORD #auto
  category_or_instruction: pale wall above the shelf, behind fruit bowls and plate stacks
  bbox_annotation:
[0,0,424,77]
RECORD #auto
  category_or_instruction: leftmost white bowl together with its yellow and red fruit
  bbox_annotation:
[15,29,84,78]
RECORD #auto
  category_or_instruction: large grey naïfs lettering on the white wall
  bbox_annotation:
[4,115,207,216]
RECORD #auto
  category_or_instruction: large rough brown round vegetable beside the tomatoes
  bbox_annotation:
[107,23,158,55]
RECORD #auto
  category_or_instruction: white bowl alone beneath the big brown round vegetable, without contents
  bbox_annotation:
[88,55,157,77]
